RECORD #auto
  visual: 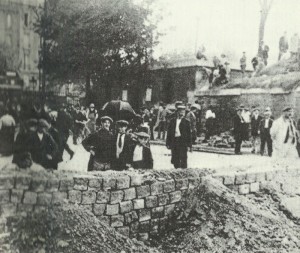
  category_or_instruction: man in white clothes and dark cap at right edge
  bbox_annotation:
[270,106,298,158]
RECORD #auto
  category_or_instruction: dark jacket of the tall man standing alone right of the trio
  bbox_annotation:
[166,118,192,148]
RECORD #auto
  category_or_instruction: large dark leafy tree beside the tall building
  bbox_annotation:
[35,0,156,105]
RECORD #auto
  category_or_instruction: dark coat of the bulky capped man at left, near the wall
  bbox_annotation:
[29,133,58,168]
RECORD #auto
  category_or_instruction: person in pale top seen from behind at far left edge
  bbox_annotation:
[0,108,16,156]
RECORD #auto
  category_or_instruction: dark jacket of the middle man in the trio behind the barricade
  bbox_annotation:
[112,134,133,170]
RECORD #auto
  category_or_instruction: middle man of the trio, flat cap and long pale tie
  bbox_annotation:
[112,120,132,170]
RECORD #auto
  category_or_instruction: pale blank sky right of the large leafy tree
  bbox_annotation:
[154,0,300,66]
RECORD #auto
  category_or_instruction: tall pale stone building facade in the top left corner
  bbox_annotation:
[0,0,43,90]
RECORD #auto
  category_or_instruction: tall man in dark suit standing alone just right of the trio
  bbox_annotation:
[166,105,192,168]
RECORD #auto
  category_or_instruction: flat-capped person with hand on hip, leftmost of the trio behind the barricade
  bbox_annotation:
[82,116,113,171]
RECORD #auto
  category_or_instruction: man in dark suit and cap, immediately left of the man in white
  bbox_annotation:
[259,109,273,157]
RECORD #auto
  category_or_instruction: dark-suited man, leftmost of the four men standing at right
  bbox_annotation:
[233,107,247,155]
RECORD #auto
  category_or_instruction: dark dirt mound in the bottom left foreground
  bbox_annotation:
[5,207,156,253]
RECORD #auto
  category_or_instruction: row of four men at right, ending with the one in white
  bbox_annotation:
[233,106,299,158]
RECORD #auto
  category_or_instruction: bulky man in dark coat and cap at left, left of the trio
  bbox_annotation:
[29,119,58,169]
